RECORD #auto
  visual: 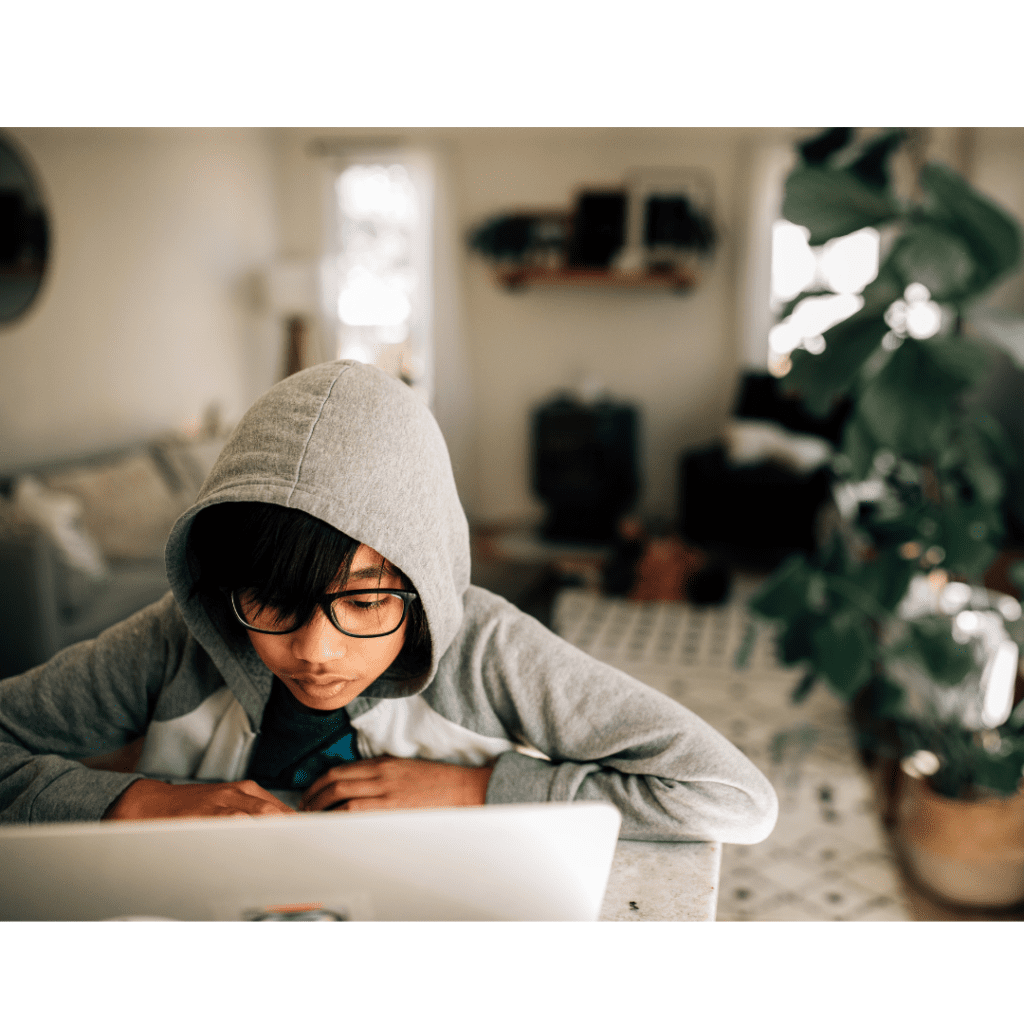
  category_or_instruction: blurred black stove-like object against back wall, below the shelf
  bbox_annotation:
[532,397,640,544]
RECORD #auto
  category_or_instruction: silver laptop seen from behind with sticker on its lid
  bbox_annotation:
[0,803,621,921]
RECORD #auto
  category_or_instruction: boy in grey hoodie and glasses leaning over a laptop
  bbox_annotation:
[0,361,777,843]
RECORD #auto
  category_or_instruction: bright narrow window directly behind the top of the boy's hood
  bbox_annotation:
[323,152,433,403]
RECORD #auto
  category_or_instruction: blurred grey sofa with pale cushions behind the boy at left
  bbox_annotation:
[0,434,226,678]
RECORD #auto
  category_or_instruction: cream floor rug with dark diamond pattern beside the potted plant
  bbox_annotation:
[553,579,911,921]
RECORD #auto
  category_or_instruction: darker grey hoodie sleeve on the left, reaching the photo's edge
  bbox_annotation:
[0,595,186,824]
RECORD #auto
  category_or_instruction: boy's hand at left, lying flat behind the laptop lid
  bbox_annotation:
[103,778,295,821]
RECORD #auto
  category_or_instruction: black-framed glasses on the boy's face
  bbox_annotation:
[229,587,420,640]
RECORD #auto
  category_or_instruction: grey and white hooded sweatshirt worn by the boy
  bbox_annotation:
[0,361,777,843]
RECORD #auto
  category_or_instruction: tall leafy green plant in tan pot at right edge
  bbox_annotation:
[752,129,1024,904]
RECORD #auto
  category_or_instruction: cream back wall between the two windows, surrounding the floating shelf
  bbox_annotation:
[458,130,743,519]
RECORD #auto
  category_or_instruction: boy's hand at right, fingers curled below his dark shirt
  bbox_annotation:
[299,755,494,811]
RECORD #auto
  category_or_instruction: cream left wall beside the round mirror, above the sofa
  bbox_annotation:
[0,128,280,471]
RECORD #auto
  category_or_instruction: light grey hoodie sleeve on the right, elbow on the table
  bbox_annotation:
[464,609,778,843]
